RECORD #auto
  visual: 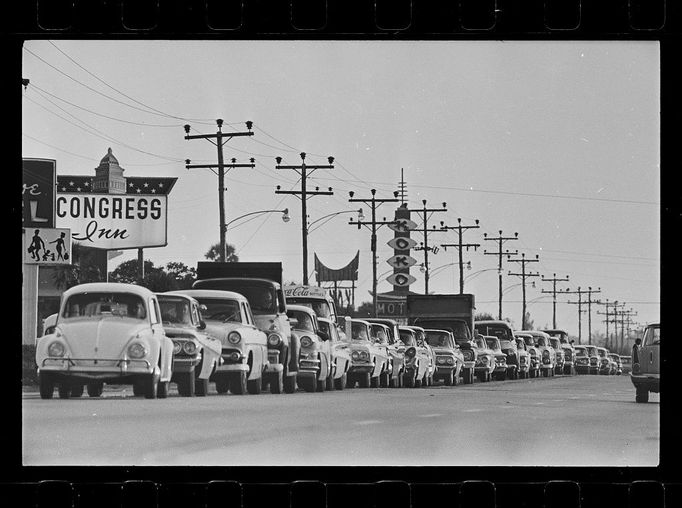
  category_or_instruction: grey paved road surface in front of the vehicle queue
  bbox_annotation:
[23,376,660,466]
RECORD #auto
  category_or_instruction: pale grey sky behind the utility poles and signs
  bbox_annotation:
[22,40,660,337]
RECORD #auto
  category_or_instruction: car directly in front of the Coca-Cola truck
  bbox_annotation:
[287,304,331,392]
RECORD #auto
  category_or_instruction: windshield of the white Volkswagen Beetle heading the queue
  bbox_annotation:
[62,293,147,319]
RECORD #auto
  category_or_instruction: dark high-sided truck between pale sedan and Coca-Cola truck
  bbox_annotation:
[192,261,300,393]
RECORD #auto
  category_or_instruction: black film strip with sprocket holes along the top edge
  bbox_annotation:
[16,0,668,37]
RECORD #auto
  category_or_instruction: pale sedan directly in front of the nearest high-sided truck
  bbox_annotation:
[169,289,266,395]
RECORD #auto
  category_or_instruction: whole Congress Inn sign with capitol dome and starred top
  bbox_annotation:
[55,148,177,250]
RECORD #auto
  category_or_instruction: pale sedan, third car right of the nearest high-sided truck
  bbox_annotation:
[345,319,390,388]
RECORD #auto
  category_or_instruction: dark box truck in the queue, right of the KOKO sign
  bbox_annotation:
[406,294,476,384]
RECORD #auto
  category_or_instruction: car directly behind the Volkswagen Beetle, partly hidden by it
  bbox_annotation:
[156,293,222,397]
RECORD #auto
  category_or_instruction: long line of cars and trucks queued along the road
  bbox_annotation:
[36,277,622,399]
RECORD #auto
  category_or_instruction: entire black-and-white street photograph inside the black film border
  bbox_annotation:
[21,38,661,468]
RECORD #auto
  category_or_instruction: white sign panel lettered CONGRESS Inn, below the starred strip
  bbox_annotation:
[56,193,168,250]
